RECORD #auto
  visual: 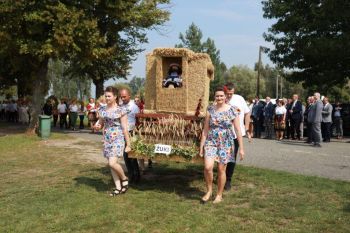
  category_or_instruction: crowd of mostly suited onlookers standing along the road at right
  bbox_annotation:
[249,92,343,147]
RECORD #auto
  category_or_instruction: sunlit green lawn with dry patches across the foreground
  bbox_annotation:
[0,134,350,232]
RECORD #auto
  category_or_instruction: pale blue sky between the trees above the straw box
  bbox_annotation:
[102,0,272,85]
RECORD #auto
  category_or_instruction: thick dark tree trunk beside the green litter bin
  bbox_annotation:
[27,59,49,134]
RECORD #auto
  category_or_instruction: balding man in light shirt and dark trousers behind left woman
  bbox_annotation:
[119,89,141,183]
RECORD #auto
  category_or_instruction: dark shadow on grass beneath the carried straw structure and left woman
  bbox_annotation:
[74,163,204,200]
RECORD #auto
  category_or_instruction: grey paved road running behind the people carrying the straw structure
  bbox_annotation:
[54,130,350,181]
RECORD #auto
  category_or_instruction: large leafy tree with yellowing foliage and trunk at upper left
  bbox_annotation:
[0,0,169,132]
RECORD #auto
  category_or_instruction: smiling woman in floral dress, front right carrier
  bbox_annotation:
[199,88,244,203]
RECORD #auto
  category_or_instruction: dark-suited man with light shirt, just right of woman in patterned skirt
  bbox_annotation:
[289,94,303,140]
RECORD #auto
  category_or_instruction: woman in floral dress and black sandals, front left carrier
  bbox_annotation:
[94,87,130,196]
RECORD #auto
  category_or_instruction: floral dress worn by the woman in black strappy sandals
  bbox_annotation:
[98,106,126,158]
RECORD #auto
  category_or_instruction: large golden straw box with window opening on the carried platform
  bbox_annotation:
[144,48,214,116]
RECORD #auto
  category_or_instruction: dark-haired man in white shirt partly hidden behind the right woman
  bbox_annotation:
[225,83,251,191]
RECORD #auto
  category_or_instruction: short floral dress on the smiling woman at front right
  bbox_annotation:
[204,106,238,164]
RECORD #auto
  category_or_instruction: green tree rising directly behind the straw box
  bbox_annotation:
[175,23,227,98]
